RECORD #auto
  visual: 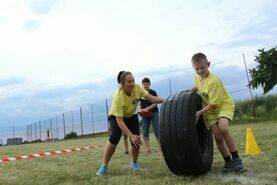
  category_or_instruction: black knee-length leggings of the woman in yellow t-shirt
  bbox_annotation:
[109,114,140,146]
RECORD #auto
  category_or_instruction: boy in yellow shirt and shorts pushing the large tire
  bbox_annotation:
[187,53,243,172]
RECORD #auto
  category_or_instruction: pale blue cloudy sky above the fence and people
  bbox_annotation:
[0,0,277,141]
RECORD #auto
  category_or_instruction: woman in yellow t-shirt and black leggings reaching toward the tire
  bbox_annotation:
[96,71,163,176]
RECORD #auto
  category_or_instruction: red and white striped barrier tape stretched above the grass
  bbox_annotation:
[0,146,101,163]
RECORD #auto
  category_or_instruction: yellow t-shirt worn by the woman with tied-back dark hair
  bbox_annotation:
[109,84,148,118]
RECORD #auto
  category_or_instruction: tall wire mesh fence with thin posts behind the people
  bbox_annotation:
[0,52,274,144]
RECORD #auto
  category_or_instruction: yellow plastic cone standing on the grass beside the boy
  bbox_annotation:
[245,128,261,155]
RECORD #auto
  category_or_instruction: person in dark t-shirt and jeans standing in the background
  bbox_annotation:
[140,77,160,153]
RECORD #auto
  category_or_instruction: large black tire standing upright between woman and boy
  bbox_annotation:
[159,92,213,175]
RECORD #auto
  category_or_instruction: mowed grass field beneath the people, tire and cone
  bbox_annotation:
[0,121,277,185]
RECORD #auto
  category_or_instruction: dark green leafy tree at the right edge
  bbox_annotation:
[249,47,277,94]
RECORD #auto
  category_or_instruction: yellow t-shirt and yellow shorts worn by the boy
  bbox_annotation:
[194,72,235,127]
